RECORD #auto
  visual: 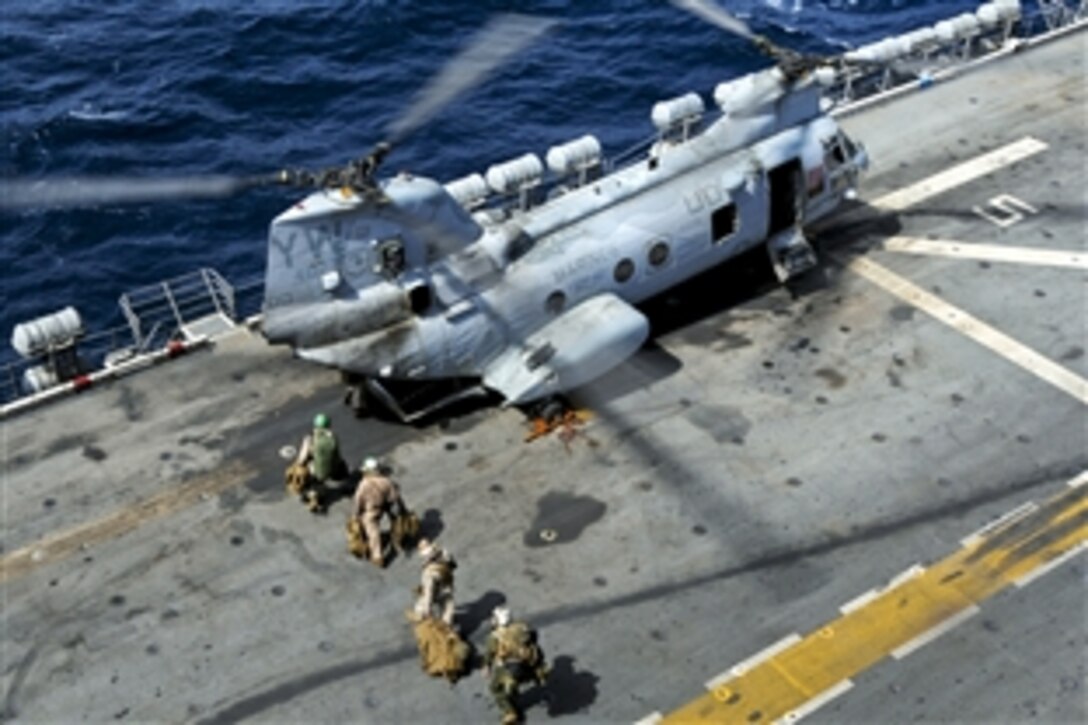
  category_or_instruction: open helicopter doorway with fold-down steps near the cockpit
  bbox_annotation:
[767,159,816,282]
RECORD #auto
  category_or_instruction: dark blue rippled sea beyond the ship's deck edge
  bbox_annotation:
[0,0,1005,359]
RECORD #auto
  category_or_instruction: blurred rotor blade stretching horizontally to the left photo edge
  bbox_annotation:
[0,174,282,210]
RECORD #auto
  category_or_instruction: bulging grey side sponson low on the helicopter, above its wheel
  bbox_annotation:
[483,293,650,404]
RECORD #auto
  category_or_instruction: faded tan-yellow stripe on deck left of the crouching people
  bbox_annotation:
[0,463,255,583]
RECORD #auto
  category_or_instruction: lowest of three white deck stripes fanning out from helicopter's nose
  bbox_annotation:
[848,257,1088,405]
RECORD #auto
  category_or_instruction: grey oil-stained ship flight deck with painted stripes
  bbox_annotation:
[0,19,1088,723]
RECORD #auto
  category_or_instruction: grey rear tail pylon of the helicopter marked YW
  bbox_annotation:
[263,174,482,347]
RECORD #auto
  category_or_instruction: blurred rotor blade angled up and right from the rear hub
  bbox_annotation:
[385,14,556,145]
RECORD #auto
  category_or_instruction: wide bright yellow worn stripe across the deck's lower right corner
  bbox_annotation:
[662,478,1088,724]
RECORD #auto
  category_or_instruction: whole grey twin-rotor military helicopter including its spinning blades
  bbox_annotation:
[4,0,867,419]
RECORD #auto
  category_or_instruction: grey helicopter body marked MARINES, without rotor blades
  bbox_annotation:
[256,71,866,403]
